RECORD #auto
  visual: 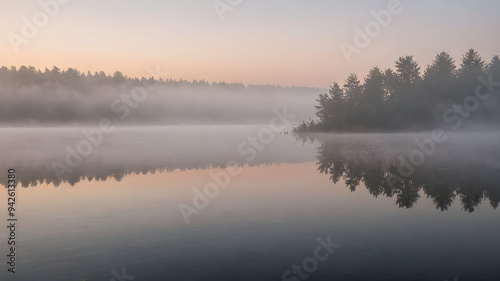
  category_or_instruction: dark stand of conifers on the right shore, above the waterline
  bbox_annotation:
[294,49,500,132]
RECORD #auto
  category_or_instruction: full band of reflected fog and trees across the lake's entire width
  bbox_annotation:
[0,126,500,212]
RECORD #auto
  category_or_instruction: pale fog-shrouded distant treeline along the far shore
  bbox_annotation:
[0,67,322,126]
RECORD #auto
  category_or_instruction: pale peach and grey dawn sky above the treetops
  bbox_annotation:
[0,0,500,88]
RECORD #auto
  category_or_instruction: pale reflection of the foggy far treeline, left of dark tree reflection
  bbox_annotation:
[0,125,314,187]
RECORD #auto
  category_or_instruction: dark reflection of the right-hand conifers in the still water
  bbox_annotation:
[308,135,500,212]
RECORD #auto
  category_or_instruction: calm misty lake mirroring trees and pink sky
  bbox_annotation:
[0,125,500,281]
